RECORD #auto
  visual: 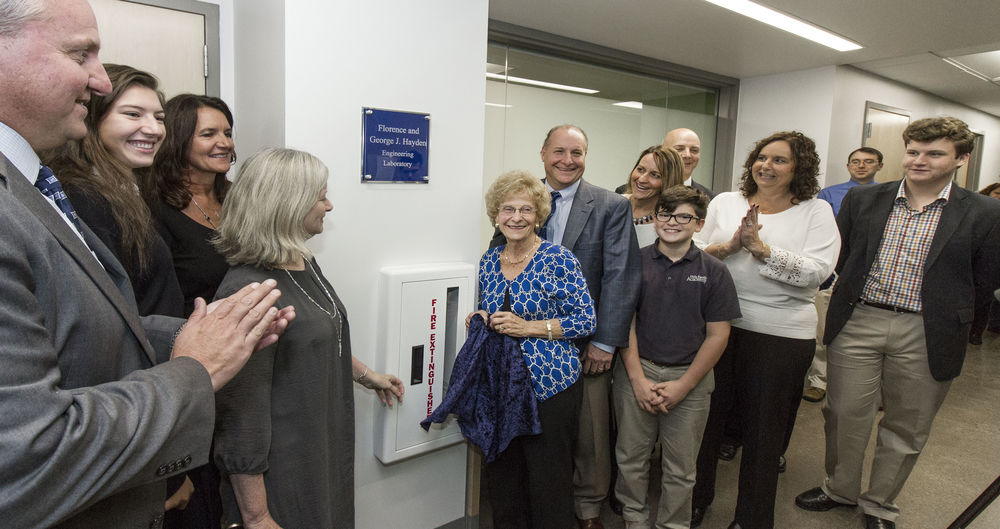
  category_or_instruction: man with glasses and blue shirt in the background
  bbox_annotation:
[802,147,882,402]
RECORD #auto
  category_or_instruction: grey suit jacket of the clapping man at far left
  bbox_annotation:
[0,154,215,529]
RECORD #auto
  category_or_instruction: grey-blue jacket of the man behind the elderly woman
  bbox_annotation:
[490,180,642,352]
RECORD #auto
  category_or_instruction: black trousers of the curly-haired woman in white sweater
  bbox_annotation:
[693,328,816,529]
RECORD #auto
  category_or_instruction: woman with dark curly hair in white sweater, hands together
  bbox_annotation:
[692,132,840,529]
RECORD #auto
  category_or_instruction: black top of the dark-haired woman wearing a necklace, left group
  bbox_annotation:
[153,198,229,317]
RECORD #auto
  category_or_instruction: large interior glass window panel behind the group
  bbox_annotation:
[484,43,719,196]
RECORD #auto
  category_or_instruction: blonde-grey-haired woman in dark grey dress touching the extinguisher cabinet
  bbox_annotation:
[214,149,404,529]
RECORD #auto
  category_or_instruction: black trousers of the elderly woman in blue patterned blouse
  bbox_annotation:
[484,381,583,529]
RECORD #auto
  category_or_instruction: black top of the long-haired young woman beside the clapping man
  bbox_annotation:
[64,185,184,317]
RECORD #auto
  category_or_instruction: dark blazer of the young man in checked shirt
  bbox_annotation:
[823,180,1000,381]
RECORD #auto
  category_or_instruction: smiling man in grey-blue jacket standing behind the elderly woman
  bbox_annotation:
[541,125,642,529]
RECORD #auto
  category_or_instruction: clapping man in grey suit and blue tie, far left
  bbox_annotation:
[0,0,294,529]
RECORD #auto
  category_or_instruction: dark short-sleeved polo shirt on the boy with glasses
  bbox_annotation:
[635,243,740,365]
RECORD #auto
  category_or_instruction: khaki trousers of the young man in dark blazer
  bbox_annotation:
[823,304,951,520]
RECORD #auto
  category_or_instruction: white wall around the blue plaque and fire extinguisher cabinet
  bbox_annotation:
[233,0,488,528]
